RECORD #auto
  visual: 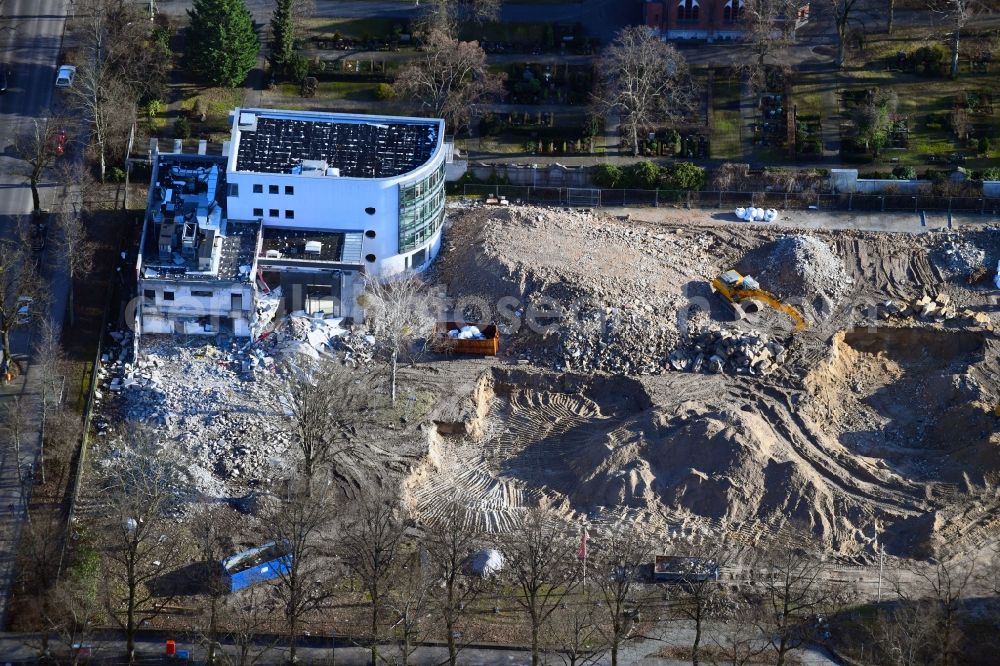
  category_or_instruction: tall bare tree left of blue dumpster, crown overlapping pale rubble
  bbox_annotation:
[97,425,190,664]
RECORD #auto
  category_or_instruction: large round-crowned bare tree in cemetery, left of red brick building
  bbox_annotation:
[594,26,695,155]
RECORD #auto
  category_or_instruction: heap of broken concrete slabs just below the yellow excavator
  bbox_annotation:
[669,325,787,376]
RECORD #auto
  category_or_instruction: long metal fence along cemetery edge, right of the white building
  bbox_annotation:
[462,185,1000,215]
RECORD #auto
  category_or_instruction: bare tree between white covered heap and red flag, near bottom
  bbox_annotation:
[504,509,580,666]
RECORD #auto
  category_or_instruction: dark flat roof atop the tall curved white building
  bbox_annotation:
[236,111,439,178]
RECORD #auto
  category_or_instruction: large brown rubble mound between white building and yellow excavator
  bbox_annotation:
[436,207,718,374]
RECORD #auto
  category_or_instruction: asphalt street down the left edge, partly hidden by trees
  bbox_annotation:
[0,0,68,623]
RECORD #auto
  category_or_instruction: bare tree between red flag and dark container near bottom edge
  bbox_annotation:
[593,526,653,666]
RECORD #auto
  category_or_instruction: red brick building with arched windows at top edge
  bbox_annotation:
[642,0,809,42]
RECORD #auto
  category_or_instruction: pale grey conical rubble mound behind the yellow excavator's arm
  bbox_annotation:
[759,235,851,303]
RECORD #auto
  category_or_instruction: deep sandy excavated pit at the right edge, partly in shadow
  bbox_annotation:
[806,328,998,482]
